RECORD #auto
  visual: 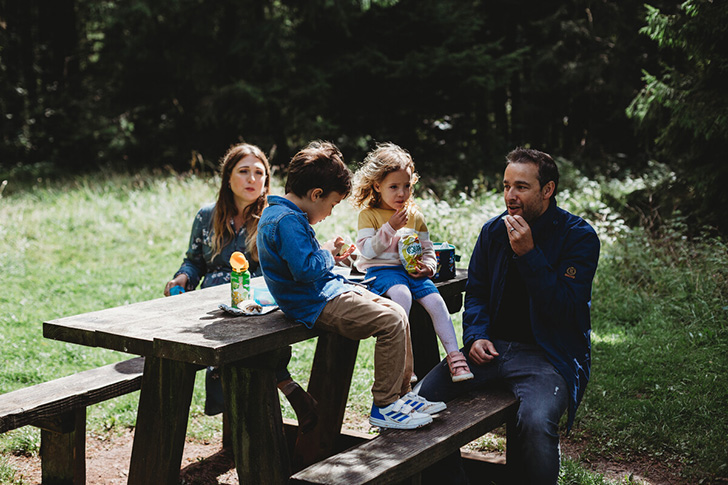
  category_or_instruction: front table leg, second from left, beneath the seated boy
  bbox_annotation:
[220,350,291,484]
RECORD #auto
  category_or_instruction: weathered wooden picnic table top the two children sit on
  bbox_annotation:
[43,270,466,366]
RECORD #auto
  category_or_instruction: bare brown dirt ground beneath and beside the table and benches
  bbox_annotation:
[1,423,689,485]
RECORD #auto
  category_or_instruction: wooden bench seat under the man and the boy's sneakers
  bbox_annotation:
[291,390,518,485]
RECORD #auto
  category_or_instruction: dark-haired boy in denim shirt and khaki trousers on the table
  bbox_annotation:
[257,142,445,429]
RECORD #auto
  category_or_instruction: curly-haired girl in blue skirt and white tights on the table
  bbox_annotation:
[352,143,473,382]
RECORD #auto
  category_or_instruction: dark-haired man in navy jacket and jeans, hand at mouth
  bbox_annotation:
[416,148,599,484]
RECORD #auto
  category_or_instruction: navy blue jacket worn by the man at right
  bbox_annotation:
[463,198,599,429]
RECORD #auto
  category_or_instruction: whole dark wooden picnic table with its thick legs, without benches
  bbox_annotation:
[43,270,466,484]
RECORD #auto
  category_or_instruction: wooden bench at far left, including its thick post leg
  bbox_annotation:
[0,357,144,484]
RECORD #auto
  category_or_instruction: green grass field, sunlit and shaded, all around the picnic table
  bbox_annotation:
[0,165,728,484]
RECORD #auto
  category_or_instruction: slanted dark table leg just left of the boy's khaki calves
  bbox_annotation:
[293,333,359,471]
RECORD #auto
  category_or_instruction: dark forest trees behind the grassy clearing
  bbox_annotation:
[0,0,728,232]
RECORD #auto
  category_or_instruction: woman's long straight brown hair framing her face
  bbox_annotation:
[211,143,270,261]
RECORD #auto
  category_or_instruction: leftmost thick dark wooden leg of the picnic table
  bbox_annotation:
[128,356,199,485]
